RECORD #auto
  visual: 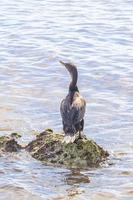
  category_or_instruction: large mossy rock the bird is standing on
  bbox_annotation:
[26,129,109,168]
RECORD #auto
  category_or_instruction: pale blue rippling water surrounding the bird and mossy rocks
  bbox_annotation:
[0,0,133,200]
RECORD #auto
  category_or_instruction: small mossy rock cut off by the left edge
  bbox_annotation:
[0,133,21,153]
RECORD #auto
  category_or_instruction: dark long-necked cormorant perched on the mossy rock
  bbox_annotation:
[60,61,86,143]
